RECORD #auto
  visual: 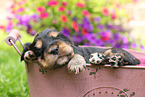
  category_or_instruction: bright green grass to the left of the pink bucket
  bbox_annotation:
[0,32,33,97]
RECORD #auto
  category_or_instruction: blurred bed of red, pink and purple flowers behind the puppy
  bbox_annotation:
[3,0,144,50]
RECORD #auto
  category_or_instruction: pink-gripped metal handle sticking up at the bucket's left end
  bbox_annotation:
[6,29,24,56]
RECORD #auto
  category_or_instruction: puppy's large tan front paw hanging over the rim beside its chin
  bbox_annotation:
[67,54,86,74]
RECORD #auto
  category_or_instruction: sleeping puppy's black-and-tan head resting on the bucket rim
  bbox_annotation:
[31,29,74,69]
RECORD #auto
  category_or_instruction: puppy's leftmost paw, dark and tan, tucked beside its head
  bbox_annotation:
[24,50,36,62]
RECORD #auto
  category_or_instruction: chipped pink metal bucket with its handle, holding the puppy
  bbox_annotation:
[6,30,145,97]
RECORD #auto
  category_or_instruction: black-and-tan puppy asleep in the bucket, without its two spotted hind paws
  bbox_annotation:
[21,29,140,74]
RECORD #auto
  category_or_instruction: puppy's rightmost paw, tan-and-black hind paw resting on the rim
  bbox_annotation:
[109,53,124,68]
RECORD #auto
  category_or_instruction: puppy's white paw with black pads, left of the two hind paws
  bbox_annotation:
[89,53,105,65]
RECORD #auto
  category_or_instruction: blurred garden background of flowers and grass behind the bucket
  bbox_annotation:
[0,0,145,97]
